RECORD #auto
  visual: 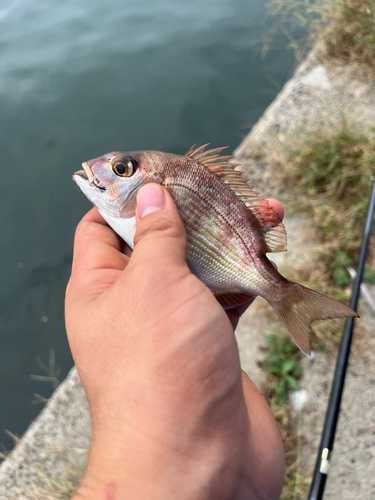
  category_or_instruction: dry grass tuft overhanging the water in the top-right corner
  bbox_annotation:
[269,0,375,79]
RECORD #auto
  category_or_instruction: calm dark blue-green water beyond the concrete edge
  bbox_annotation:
[0,0,293,448]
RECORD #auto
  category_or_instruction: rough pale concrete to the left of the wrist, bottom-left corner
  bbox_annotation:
[0,368,90,500]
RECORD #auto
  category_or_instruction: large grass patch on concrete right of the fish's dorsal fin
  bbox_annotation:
[270,122,375,290]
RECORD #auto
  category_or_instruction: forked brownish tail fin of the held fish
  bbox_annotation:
[270,281,359,356]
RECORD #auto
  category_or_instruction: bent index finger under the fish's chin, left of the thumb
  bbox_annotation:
[72,208,129,276]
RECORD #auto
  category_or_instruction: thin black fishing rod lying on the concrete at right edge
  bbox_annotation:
[309,177,375,500]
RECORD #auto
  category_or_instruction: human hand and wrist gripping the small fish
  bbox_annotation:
[66,185,284,500]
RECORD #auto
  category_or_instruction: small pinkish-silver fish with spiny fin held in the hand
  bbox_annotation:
[73,144,358,355]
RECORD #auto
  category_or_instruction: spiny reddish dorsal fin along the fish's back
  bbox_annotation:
[186,144,286,252]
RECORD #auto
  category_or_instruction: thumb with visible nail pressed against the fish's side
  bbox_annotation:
[131,184,187,268]
